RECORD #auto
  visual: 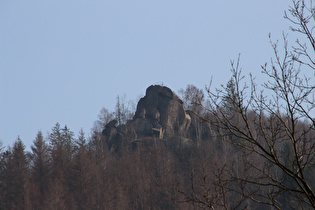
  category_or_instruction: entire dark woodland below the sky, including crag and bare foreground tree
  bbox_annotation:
[0,0,315,209]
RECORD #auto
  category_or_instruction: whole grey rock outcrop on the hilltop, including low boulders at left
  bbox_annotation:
[103,85,191,150]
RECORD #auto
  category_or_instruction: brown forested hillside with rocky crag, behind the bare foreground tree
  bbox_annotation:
[0,79,315,209]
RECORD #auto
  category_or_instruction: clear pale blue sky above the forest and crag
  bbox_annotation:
[0,0,298,148]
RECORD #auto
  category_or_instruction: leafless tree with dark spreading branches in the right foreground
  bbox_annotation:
[200,0,315,209]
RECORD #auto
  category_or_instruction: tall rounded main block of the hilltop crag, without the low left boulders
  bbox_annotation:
[130,85,190,138]
